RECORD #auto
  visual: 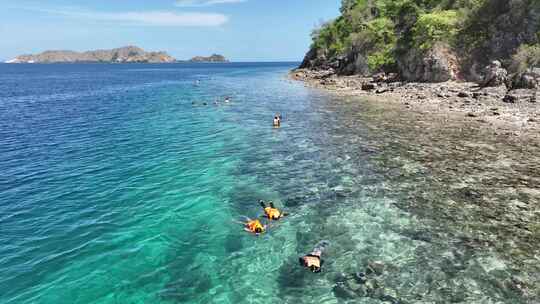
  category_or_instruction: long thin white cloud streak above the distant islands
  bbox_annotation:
[20,7,228,27]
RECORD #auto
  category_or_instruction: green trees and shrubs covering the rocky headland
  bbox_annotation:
[312,0,540,72]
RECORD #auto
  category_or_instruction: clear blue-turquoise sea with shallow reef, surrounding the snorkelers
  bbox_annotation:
[0,63,540,304]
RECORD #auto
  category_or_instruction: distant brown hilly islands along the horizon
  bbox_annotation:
[5,46,229,63]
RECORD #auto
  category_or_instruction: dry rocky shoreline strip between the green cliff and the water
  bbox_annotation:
[289,69,540,139]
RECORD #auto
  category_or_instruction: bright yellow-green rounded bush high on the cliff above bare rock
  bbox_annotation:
[412,10,458,50]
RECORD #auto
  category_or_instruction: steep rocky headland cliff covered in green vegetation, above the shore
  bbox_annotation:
[301,0,540,82]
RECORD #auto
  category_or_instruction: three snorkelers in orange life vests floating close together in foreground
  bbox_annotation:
[242,200,329,272]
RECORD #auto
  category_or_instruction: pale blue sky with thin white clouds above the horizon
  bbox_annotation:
[0,0,341,61]
